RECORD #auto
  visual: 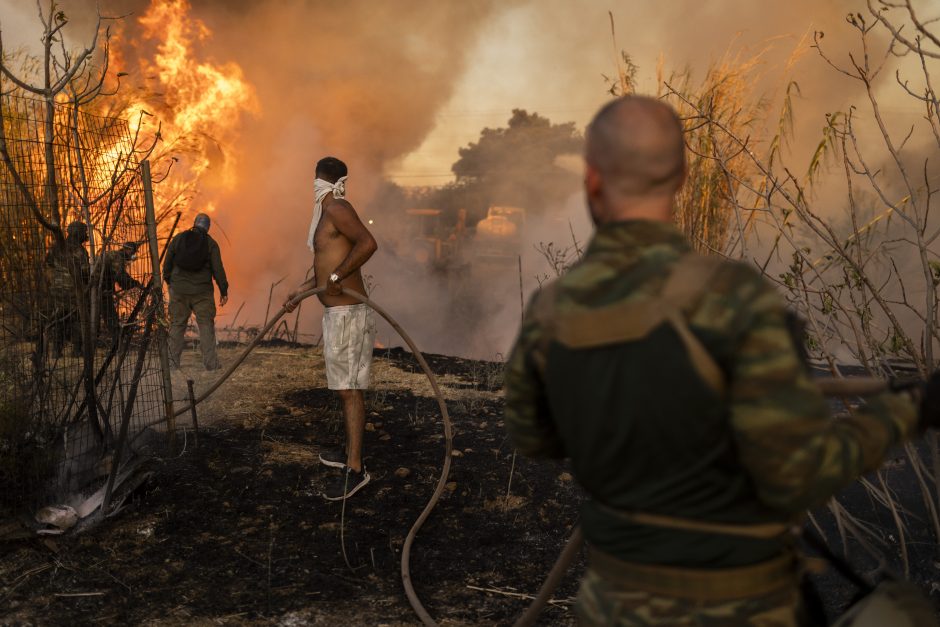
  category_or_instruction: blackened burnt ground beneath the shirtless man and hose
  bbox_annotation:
[0,344,938,625]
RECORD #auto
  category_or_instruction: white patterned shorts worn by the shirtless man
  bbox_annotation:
[323,304,375,390]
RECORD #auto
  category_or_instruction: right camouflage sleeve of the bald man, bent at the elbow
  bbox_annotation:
[730,274,917,513]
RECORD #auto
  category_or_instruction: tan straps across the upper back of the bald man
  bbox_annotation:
[537,252,726,394]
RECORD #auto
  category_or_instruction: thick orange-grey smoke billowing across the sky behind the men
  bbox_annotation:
[0,0,932,357]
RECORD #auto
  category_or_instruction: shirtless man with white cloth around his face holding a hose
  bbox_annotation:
[284,157,378,501]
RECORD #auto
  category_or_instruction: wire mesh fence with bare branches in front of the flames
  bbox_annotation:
[0,95,165,513]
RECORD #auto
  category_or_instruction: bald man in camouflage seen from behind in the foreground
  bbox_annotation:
[506,97,918,625]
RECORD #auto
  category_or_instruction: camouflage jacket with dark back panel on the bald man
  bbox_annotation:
[506,221,917,568]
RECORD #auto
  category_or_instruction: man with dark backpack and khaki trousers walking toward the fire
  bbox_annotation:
[163,213,228,370]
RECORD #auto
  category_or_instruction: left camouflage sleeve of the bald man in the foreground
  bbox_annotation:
[505,292,565,458]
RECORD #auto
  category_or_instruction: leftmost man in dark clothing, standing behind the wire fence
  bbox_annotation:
[46,221,89,357]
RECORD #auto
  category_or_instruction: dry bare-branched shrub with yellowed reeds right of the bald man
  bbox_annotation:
[600,0,940,571]
